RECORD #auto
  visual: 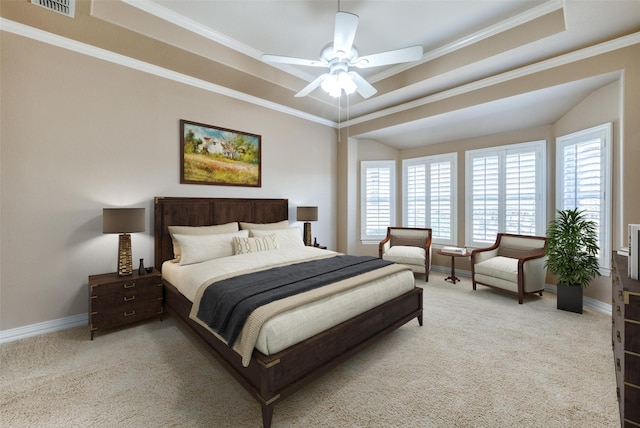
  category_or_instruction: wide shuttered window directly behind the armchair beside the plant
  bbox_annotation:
[465,141,546,247]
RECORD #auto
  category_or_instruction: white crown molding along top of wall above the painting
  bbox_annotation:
[0,18,338,128]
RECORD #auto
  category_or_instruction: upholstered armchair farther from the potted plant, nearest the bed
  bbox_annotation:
[378,227,431,281]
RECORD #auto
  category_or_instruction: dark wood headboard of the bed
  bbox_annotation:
[153,196,289,270]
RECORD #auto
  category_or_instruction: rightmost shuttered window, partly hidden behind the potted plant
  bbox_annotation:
[556,123,611,275]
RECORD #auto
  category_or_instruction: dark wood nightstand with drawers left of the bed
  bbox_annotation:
[89,269,163,340]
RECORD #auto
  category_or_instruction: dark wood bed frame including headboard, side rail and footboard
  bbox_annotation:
[154,197,422,428]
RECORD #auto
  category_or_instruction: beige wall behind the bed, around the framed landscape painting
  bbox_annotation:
[0,32,337,330]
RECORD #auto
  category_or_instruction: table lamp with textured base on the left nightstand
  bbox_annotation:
[102,208,145,276]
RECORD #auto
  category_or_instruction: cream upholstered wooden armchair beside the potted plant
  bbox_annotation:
[471,233,547,304]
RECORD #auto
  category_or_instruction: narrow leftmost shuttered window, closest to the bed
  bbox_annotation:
[360,161,396,243]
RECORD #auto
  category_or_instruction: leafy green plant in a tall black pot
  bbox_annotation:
[545,208,600,314]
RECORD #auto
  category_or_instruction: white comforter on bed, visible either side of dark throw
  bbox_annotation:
[162,247,415,364]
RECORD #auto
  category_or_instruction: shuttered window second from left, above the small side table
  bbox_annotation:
[402,153,457,245]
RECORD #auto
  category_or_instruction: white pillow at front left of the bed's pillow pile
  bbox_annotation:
[173,230,249,266]
